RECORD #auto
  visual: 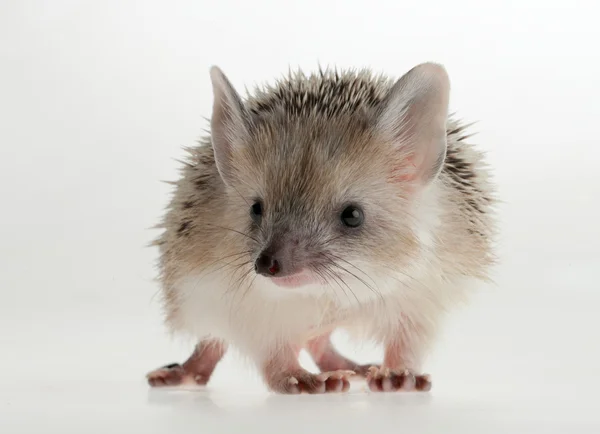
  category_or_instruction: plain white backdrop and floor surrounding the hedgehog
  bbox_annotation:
[0,0,600,433]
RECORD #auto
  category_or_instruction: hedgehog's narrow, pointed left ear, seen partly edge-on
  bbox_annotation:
[210,66,248,183]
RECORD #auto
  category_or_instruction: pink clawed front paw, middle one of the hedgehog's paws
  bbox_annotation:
[268,370,355,394]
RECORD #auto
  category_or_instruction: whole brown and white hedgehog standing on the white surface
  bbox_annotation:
[148,63,494,393]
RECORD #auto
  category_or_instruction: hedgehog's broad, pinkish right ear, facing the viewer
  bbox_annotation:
[377,63,450,185]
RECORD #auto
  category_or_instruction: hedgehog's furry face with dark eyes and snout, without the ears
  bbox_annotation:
[230,122,418,296]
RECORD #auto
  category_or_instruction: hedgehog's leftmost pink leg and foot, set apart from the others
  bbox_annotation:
[146,339,227,387]
